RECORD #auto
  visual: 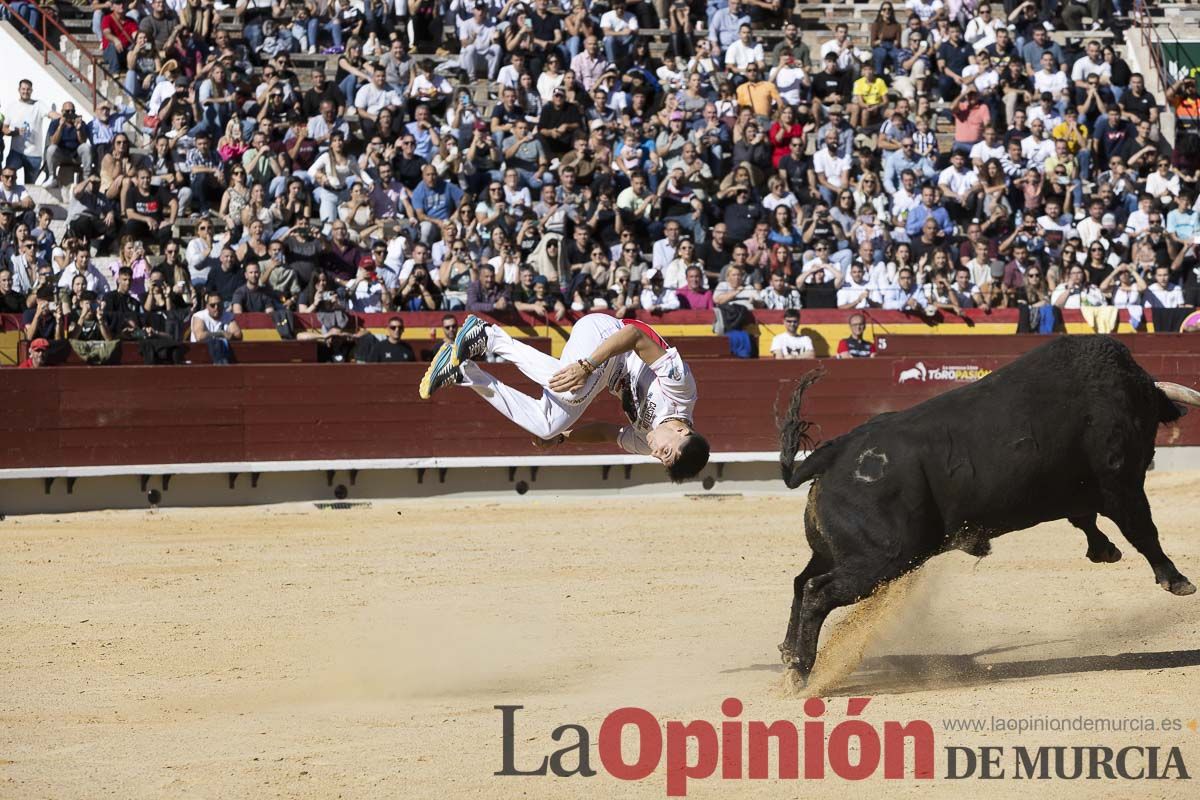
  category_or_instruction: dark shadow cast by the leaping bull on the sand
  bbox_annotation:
[725,642,1200,696]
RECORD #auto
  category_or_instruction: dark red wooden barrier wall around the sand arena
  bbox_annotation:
[0,336,1200,468]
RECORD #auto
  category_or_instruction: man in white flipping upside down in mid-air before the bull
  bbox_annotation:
[420,314,708,482]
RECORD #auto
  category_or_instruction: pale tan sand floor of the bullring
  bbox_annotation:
[0,473,1200,799]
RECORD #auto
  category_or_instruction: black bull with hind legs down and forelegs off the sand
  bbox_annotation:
[780,336,1200,679]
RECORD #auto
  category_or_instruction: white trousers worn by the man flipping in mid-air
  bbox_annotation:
[453,314,620,439]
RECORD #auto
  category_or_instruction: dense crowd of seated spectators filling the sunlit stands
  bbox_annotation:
[7,0,1200,367]
